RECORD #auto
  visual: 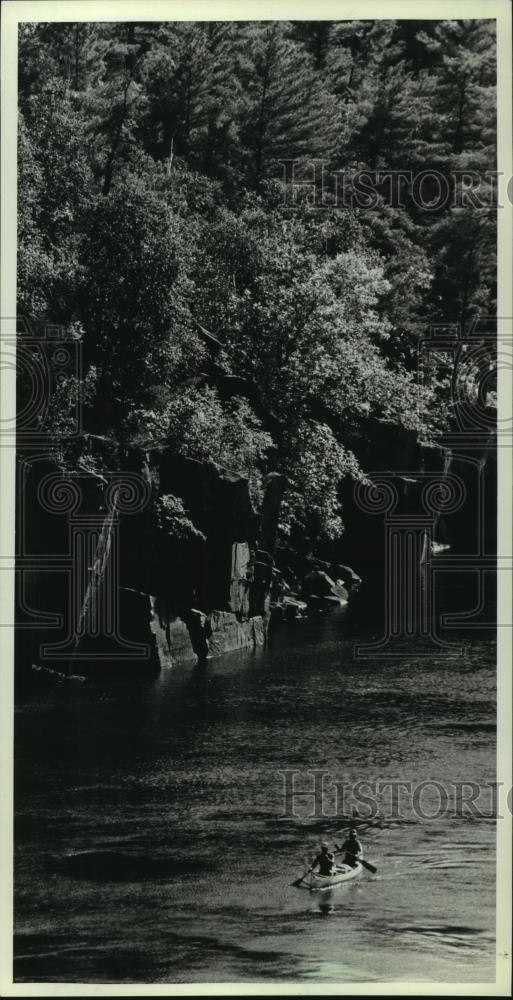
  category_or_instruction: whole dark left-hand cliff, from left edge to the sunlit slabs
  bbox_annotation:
[17,440,284,673]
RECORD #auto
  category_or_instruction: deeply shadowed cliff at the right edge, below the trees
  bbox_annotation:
[334,425,497,628]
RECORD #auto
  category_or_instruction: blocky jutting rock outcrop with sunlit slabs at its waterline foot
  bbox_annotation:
[131,452,283,664]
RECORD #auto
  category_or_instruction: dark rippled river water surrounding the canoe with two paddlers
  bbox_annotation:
[14,614,495,989]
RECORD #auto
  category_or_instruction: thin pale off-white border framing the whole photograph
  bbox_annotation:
[0,0,513,997]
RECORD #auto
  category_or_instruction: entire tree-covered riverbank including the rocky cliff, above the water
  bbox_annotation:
[17,20,496,675]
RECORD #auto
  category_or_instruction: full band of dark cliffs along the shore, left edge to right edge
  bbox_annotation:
[16,414,496,674]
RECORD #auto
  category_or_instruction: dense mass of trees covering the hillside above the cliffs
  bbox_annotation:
[18,21,496,546]
